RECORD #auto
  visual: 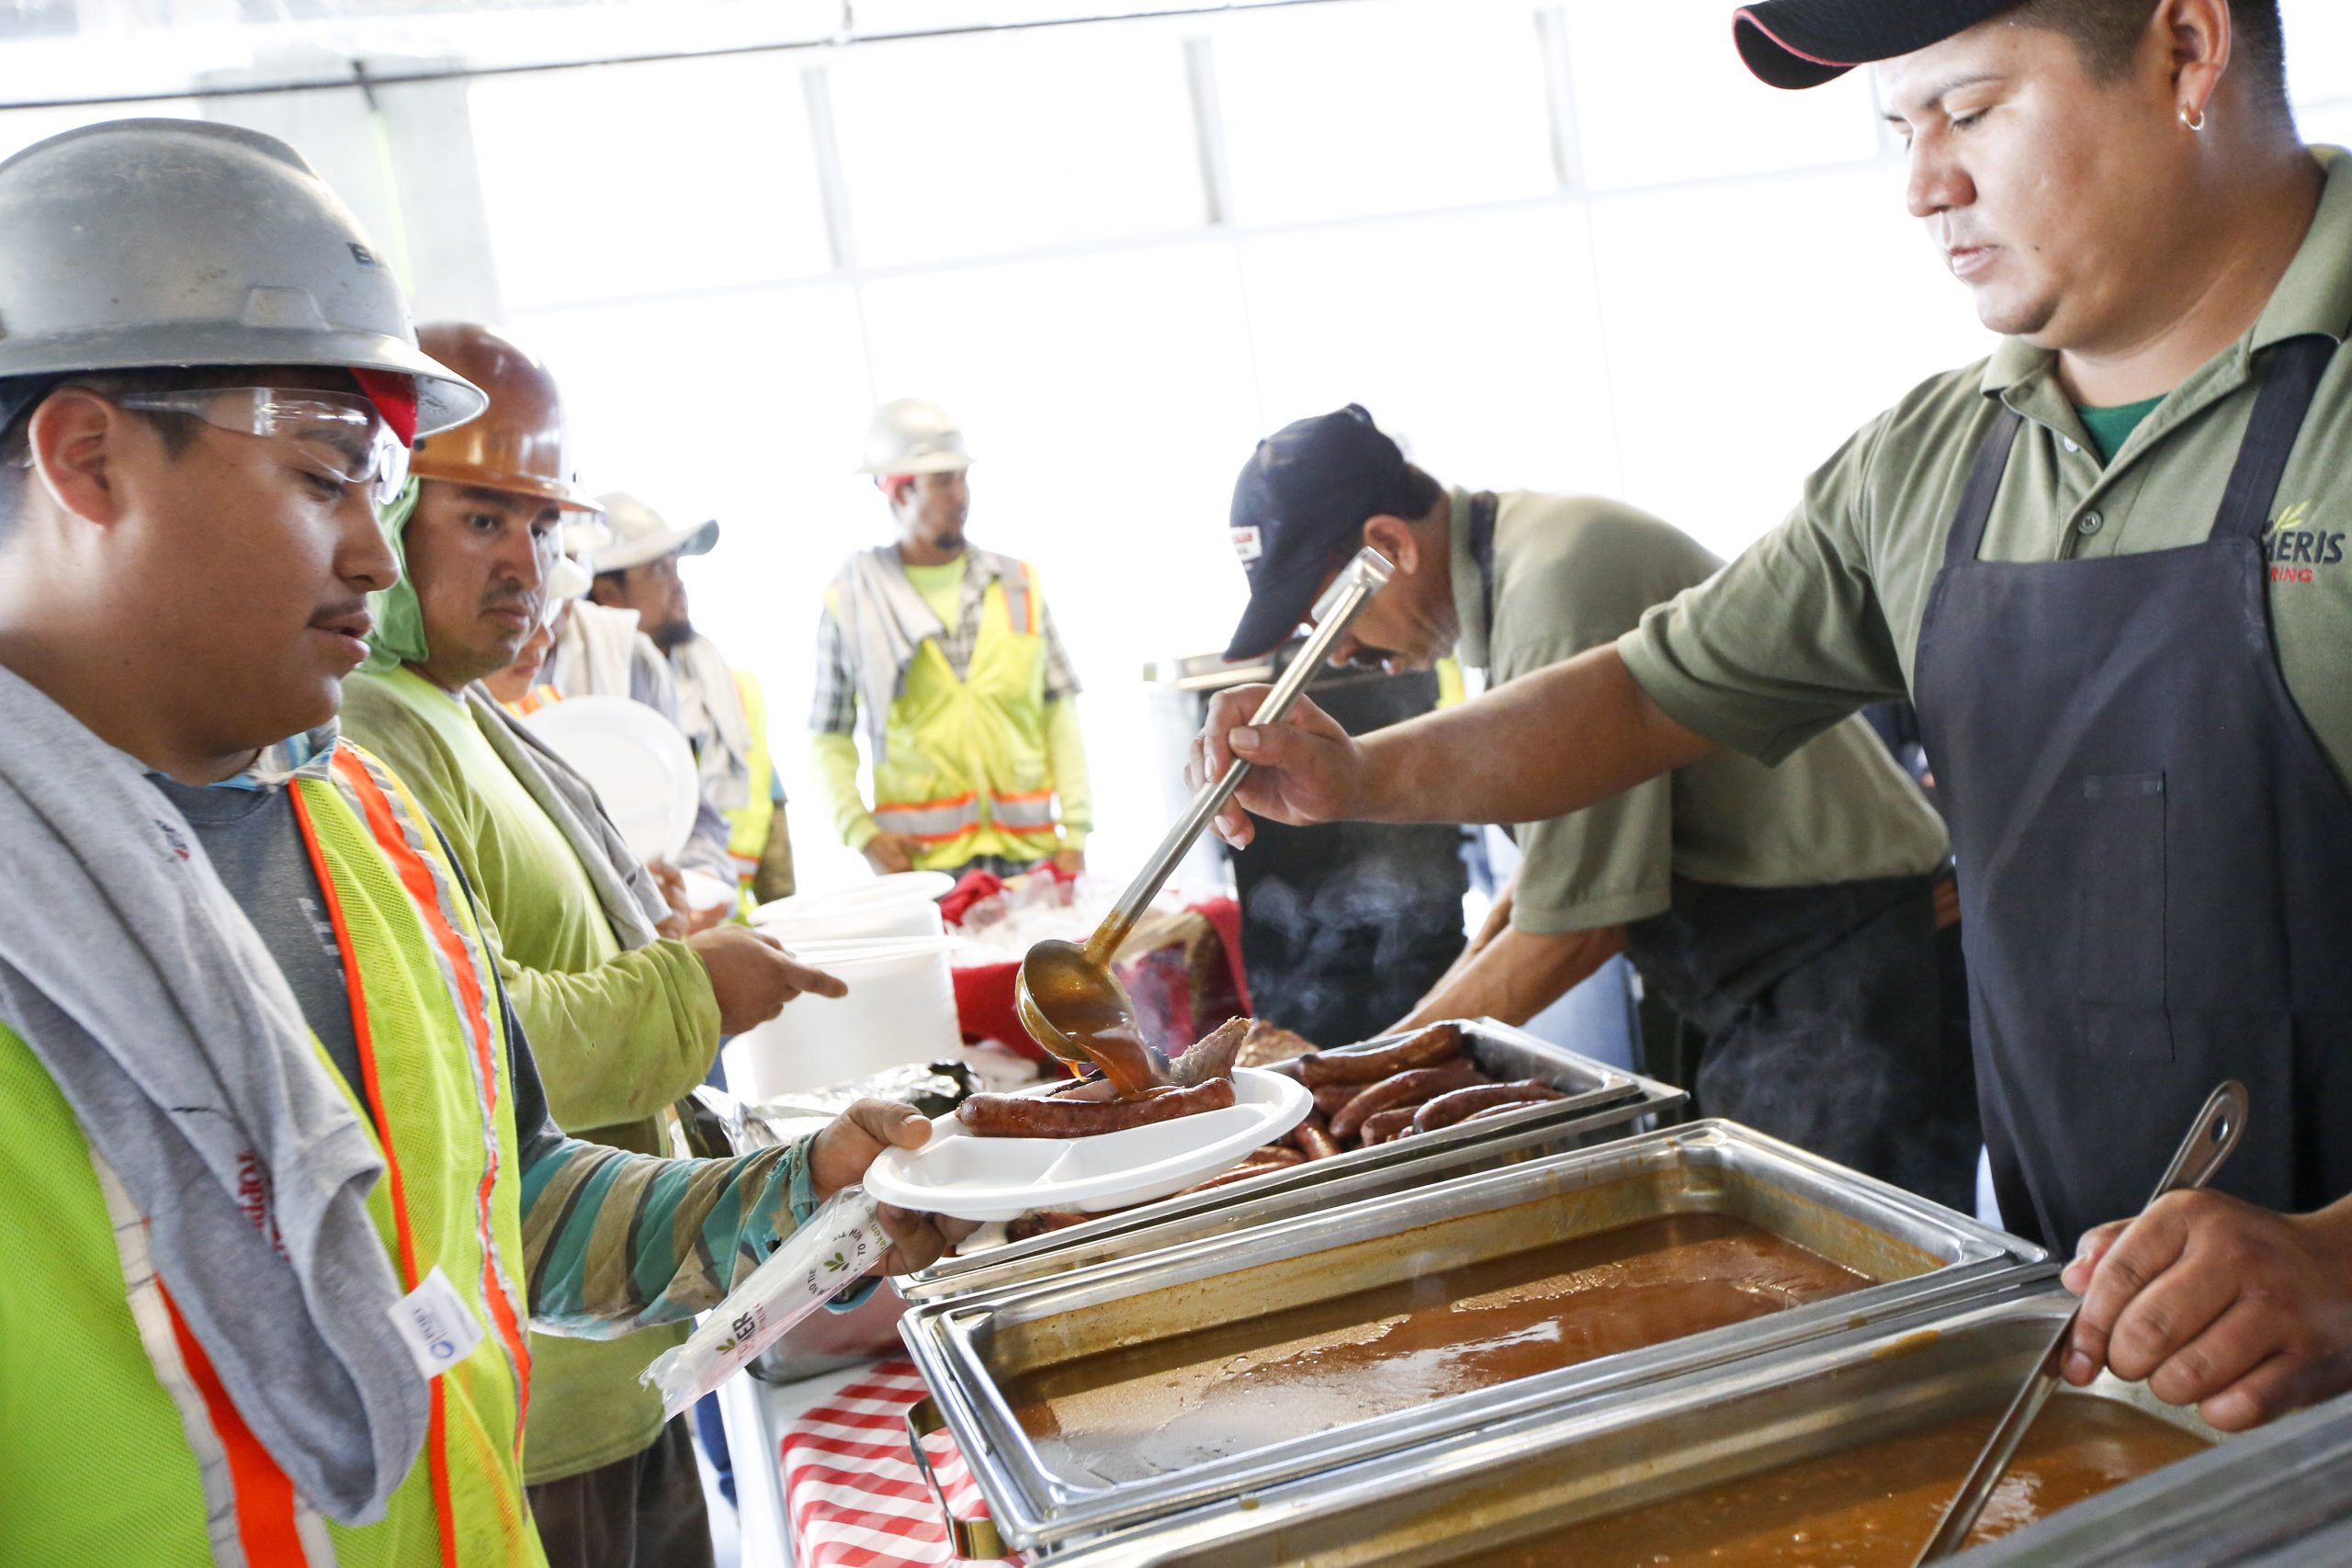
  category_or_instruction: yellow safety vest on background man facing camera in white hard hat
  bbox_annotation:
[835,562,1061,870]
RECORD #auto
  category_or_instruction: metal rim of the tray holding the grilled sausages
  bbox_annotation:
[896,1018,1689,1303]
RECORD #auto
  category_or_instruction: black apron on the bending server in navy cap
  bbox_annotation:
[1467,491,1978,1208]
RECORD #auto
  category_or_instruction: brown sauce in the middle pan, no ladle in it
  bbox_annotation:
[1004,1213,1872,1483]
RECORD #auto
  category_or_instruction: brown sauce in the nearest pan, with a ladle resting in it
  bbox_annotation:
[1446,1394,2206,1568]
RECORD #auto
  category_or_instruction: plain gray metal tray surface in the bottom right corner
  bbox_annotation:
[1969,1394,2352,1568]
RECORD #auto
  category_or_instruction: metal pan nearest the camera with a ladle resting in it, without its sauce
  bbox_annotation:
[1025,1277,2201,1568]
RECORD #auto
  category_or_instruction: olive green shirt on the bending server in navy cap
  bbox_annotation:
[1452,491,1950,936]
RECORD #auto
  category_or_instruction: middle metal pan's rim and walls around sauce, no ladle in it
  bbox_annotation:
[899,1122,2051,1551]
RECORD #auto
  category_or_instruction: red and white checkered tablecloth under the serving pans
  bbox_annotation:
[781,1361,1021,1568]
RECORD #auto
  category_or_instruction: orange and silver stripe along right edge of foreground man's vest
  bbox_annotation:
[320,745,532,1410]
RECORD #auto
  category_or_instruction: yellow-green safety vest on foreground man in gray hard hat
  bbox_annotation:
[0,743,546,1568]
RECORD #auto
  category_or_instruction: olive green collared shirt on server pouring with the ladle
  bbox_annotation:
[1618,148,2352,778]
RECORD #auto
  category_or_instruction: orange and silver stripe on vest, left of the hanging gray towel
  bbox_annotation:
[89,1149,334,1568]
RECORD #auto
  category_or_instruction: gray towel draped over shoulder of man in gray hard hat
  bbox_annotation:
[0,668,430,1523]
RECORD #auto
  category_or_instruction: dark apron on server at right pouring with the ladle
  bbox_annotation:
[1912,339,2352,1251]
